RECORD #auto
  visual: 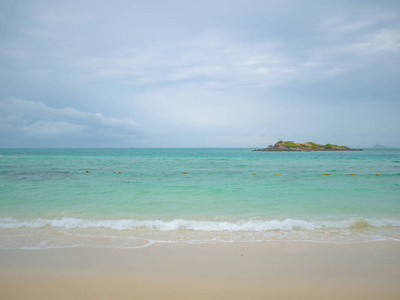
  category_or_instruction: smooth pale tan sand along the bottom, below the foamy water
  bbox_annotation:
[0,241,400,300]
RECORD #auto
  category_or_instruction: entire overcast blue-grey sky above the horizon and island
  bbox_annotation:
[0,0,400,148]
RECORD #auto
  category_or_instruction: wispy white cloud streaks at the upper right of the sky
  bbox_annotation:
[299,13,400,83]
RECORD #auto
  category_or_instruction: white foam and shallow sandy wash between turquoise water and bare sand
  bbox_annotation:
[0,217,400,249]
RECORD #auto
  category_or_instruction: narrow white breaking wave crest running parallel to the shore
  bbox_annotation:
[0,217,400,232]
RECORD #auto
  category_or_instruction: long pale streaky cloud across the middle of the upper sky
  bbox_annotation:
[69,32,296,88]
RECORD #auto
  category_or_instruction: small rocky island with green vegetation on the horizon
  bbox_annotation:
[253,141,363,152]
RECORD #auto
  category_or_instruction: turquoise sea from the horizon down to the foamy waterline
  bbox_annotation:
[0,149,400,249]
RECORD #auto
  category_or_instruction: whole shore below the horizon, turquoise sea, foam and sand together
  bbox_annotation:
[0,149,400,299]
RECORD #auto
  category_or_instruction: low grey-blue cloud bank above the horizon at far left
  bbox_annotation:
[0,98,142,147]
